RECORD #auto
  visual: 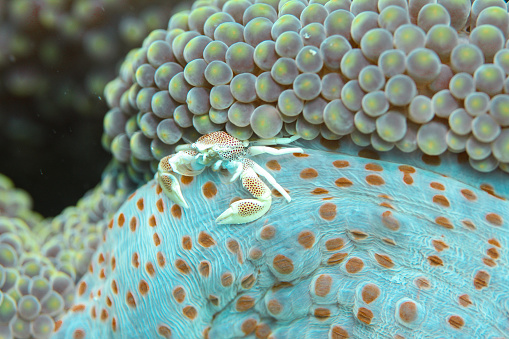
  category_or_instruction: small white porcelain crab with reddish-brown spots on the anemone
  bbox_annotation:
[156,131,303,224]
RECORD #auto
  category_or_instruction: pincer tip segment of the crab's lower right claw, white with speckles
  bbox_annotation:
[216,197,272,225]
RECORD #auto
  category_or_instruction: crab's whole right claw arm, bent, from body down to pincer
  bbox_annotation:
[216,159,276,224]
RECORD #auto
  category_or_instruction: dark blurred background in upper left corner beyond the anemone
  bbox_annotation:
[0,0,187,217]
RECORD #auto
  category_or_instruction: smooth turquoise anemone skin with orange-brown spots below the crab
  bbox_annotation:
[55,141,509,339]
